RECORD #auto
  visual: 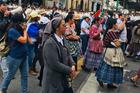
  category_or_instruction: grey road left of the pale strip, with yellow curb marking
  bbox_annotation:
[0,58,85,93]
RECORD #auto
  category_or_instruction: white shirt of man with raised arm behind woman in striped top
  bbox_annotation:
[117,19,127,42]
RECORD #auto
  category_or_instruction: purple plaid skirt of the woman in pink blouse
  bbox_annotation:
[84,50,102,69]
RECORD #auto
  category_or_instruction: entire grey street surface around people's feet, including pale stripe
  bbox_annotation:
[0,59,140,93]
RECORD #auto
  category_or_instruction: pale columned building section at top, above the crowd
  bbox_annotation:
[45,0,102,11]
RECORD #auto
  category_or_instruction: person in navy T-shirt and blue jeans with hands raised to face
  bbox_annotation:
[0,14,28,93]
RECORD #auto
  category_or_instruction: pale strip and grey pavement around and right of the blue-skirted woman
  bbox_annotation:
[77,59,140,93]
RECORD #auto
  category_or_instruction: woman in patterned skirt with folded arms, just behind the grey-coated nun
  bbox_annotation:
[65,14,81,70]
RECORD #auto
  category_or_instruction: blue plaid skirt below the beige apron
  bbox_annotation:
[96,61,123,84]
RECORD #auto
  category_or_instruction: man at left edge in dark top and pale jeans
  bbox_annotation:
[0,1,10,77]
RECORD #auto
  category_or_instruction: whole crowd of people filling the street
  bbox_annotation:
[0,2,140,93]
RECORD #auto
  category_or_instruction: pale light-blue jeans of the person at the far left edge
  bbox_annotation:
[0,57,8,78]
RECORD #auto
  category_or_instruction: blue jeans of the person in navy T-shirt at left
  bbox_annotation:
[0,56,28,93]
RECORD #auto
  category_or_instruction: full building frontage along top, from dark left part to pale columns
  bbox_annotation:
[4,0,103,11]
